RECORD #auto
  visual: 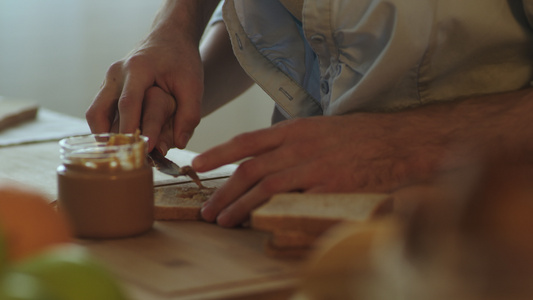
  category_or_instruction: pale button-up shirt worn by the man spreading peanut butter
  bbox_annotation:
[215,0,533,121]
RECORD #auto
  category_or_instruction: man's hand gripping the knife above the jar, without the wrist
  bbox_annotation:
[86,35,203,153]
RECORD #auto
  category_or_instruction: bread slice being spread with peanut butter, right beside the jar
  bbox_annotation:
[154,179,225,221]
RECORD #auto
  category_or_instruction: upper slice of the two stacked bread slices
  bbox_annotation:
[251,193,393,235]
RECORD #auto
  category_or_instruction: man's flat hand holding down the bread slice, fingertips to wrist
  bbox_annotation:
[193,114,442,226]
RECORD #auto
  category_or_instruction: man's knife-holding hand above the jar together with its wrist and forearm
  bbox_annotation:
[86,0,218,153]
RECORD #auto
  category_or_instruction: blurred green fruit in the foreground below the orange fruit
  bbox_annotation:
[14,244,126,300]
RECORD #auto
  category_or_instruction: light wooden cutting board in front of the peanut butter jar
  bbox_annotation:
[80,221,301,300]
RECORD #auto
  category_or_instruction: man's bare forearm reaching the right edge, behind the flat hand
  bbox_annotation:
[391,89,533,169]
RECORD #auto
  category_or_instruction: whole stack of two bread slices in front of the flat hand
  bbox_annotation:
[251,193,393,259]
